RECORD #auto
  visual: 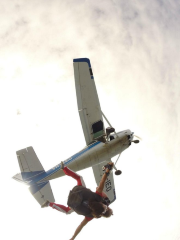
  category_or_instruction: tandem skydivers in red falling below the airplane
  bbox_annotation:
[41,162,113,240]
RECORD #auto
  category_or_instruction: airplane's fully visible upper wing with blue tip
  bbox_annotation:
[73,58,105,145]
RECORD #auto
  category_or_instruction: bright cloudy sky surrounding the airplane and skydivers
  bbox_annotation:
[0,0,180,240]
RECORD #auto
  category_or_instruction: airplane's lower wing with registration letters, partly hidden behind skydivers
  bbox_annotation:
[92,161,116,203]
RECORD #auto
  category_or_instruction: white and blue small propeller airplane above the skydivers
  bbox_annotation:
[13,58,139,206]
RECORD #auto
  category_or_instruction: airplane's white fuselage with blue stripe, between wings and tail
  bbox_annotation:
[38,130,133,182]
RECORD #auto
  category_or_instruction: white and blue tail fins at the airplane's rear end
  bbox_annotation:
[13,147,55,205]
